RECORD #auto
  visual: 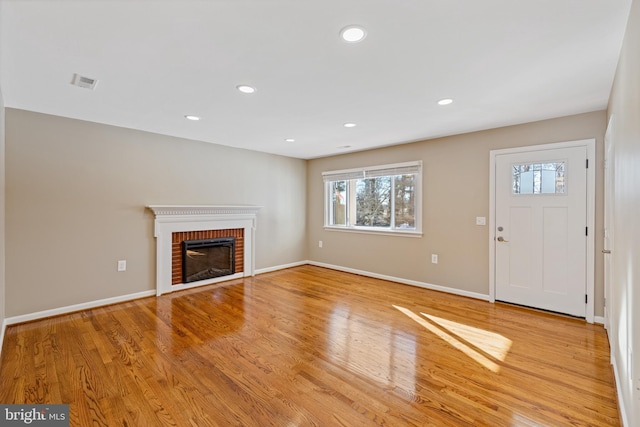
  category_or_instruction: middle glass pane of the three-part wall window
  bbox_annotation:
[355,176,391,227]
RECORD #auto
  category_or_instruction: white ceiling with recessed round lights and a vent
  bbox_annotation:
[0,0,631,159]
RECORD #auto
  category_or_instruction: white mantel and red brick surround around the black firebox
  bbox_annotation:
[148,205,260,296]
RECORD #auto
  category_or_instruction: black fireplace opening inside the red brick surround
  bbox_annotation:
[182,237,236,283]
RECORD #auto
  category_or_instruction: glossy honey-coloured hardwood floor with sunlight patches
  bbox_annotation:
[0,266,619,426]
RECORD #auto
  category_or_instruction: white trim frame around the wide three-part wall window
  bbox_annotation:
[322,160,422,237]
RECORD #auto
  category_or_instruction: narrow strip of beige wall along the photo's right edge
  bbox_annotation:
[608,0,640,426]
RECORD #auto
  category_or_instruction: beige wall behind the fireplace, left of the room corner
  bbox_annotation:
[6,109,306,317]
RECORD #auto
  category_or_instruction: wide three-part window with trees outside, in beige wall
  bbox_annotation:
[322,162,422,233]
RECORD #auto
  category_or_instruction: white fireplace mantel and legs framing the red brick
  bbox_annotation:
[148,205,260,296]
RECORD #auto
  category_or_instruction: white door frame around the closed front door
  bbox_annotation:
[489,138,597,323]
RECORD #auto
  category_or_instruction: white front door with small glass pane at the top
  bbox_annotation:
[494,146,588,317]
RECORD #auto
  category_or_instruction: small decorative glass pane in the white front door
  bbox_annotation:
[512,162,565,194]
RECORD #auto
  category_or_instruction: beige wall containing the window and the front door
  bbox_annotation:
[307,111,606,316]
